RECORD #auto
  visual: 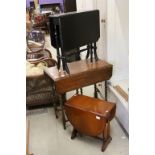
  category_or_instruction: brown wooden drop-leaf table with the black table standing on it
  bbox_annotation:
[44,59,112,129]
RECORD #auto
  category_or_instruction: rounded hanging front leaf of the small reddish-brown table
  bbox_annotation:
[65,106,106,136]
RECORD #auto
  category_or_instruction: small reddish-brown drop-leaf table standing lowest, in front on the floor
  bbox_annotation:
[65,95,116,151]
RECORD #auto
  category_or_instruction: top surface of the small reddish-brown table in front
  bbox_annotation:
[65,95,116,120]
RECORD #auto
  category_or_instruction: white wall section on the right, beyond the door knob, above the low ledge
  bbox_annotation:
[107,0,129,81]
